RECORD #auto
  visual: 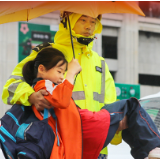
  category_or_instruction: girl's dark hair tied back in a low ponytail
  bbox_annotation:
[22,47,68,85]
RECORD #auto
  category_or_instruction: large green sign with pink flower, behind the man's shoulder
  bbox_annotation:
[18,22,58,62]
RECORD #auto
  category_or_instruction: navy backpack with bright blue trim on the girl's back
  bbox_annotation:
[0,104,55,159]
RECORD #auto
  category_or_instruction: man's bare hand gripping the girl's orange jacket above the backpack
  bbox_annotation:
[29,90,52,111]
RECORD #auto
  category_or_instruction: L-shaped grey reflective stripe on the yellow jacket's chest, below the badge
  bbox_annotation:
[93,60,105,103]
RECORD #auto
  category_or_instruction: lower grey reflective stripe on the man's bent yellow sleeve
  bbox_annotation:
[7,82,21,104]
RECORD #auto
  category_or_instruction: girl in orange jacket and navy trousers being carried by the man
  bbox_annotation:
[23,48,160,159]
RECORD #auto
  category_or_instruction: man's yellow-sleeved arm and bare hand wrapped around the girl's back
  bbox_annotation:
[2,51,50,110]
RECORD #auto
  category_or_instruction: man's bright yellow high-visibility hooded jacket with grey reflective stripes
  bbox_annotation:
[2,13,120,152]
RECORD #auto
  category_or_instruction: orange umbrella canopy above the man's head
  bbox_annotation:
[0,1,145,24]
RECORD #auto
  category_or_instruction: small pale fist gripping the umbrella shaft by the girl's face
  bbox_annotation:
[68,58,82,75]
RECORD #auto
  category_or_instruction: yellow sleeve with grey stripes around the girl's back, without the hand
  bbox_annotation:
[2,51,37,106]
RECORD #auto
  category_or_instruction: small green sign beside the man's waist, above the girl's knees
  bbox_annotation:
[115,83,140,100]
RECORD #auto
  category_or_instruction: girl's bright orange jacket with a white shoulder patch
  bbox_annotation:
[32,80,82,159]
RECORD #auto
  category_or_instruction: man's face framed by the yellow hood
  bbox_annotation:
[73,15,96,37]
